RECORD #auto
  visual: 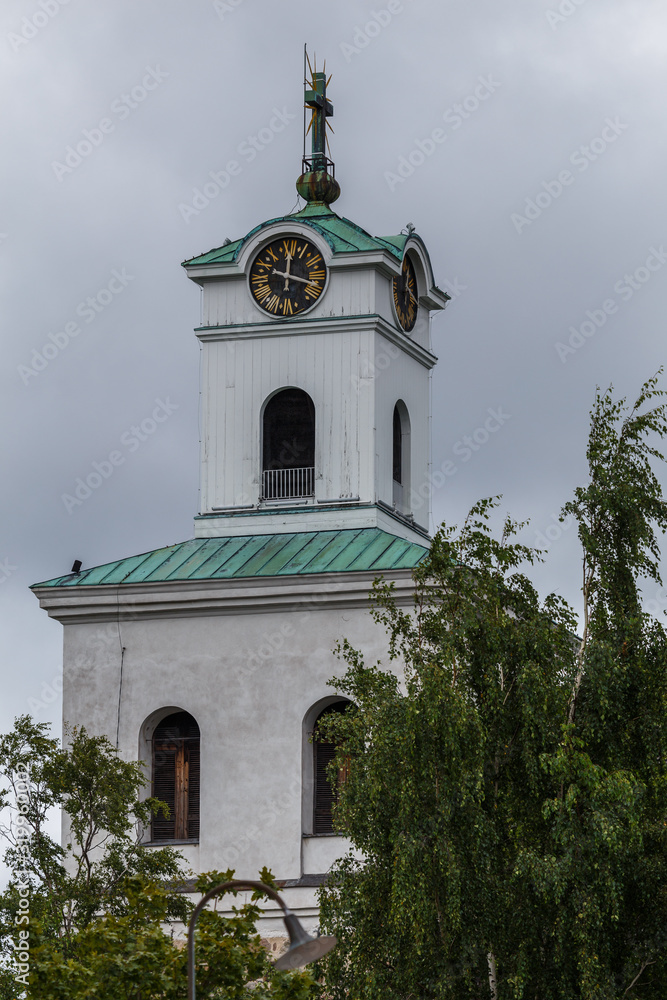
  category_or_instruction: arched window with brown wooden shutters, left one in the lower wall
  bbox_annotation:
[152,712,199,840]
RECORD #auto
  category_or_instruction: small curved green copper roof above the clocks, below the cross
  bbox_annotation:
[183,204,408,267]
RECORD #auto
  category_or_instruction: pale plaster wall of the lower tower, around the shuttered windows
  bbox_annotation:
[63,579,396,879]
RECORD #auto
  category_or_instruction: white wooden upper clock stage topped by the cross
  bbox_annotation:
[183,73,448,540]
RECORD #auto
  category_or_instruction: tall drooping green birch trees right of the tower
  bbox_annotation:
[321,379,667,1000]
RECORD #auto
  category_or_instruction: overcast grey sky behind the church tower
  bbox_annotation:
[0,0,667,730]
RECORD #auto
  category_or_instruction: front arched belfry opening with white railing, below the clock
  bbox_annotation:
[262,387,315,500]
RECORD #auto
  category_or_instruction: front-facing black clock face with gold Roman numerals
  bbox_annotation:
[250,236,327,317]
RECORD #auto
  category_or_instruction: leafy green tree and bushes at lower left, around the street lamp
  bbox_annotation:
[0,716,316,1000]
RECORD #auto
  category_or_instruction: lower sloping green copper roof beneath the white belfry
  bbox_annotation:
[33,528,427,588]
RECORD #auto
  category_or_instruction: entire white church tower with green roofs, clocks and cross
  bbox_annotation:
[32,64,448,937]
